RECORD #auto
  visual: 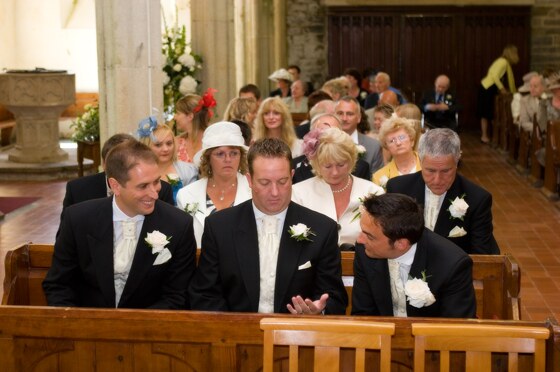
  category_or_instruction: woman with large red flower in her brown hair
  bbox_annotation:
[173,88,216,162]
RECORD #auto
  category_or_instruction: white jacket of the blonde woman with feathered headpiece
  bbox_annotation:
[292,176,385,245]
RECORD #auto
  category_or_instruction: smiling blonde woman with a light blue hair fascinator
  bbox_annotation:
[138,118,198,204]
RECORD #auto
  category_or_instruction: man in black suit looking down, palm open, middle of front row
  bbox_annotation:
[189,138,348,314]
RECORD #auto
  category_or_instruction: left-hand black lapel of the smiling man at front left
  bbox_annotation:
[86,199,115,307]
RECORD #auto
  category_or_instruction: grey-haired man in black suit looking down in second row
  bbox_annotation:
[387,128,500,254]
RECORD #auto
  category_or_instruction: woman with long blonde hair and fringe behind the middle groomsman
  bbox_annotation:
[253,97,302,158]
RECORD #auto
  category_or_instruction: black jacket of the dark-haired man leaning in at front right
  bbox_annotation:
[352,229,476,318]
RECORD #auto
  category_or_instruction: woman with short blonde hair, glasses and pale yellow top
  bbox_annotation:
[373,117,422,188]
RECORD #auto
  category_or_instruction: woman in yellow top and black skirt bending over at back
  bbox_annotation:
[476,44,519,143]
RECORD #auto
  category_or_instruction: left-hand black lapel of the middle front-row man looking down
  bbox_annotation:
[232,201,260,312]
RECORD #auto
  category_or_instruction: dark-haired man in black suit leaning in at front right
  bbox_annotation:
[352,194,476,318]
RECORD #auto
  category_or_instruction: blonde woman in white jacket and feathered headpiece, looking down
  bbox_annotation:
[292,128,384,249]
